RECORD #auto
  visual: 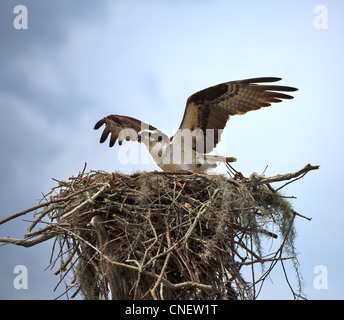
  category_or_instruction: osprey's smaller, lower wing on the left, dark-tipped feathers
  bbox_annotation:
[94,114,156,147]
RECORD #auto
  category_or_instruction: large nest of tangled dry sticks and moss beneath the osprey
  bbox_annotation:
[0,165,318,299]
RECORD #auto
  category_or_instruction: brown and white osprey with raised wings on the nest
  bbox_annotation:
[94,77,298,172]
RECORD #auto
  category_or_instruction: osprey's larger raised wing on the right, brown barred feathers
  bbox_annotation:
[179,77,298,153]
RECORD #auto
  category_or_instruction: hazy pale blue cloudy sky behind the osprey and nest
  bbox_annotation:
[0,0,344,299]
